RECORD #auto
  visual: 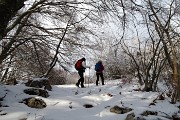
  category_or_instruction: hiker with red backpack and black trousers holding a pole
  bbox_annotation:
[75,57,90,88]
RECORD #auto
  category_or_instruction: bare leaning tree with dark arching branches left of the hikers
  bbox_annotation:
[0,0,103,82]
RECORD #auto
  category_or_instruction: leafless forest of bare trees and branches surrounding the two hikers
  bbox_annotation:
[0,0,180,103]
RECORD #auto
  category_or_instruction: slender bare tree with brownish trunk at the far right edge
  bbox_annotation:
[148,0,180,103]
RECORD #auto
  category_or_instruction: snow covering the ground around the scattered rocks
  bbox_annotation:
[0,80,179,120]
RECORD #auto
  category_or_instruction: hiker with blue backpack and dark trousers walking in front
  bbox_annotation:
[95,60,104,86]
